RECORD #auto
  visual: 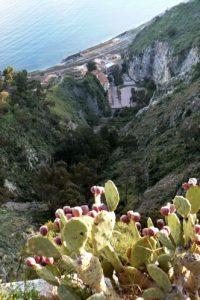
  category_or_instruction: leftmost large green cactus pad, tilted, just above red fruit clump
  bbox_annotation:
[27,236,60,258]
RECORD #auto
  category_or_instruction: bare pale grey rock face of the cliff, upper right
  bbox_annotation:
[129,41,200,85]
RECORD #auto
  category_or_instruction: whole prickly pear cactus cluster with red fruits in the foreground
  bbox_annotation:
[26,178,200,300]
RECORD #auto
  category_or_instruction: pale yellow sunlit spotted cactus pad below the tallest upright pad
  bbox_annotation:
[92,211,115,252]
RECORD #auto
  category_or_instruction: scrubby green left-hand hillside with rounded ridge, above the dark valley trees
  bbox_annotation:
[0,71,110,205]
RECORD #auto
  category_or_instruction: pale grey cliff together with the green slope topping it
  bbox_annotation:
[129,0,200,85]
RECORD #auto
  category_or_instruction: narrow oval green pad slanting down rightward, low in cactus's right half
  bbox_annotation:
[147,264,171,293]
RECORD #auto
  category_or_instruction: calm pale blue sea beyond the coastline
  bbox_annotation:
[0,0,184,71]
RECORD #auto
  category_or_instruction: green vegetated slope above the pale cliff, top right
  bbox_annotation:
[130,0,200,55]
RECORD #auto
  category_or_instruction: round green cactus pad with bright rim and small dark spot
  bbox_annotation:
[62,218,88,253]
